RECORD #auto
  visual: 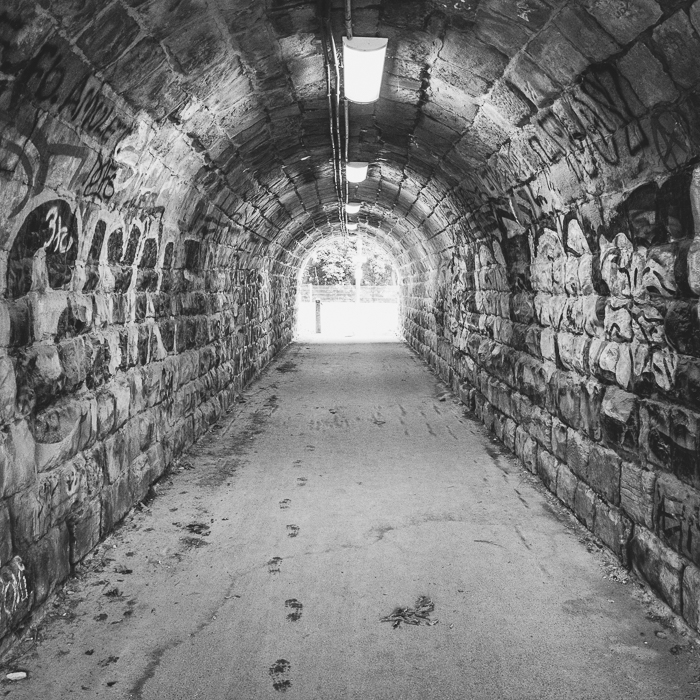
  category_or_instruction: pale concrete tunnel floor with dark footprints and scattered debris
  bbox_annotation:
[0,342,700,700]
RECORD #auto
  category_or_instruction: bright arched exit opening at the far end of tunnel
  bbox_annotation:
[295,236,399,343]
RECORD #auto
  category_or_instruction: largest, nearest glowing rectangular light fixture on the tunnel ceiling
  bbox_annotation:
[343,37,389,104]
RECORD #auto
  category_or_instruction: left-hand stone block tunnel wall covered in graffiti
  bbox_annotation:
[0,34,295,649]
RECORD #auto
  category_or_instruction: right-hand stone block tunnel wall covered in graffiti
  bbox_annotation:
[402,20,700,629]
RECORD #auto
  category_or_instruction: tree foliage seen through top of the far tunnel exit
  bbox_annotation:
[302,236,396,287]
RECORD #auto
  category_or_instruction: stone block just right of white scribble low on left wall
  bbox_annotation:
[24,524,70,605]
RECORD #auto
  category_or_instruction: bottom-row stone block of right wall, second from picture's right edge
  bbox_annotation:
[630,526,684,615]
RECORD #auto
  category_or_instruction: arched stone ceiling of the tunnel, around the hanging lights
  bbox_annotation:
[20,0,683,268]
